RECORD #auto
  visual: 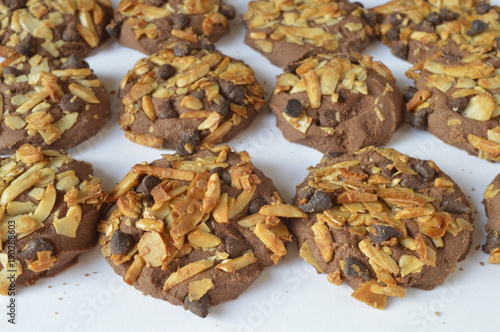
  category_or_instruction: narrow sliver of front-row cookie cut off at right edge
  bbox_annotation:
[483,174,500,264]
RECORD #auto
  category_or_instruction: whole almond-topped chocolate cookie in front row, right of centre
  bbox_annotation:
[289,148,473,309]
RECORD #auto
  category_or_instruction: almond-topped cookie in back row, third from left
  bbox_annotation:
[243,0,373,67]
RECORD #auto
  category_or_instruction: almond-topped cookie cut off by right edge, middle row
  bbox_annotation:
[406,53,500,162]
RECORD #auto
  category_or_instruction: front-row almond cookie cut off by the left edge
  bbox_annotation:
[0,144,107,295]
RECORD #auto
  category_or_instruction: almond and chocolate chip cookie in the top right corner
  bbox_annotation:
[371,0,500,63]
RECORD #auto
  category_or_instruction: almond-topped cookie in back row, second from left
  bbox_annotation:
[106,0,236,56]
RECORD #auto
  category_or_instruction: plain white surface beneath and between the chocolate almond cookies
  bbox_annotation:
[0,0,500,332]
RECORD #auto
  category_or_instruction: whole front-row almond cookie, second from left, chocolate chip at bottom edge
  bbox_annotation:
[99,146,298,317]
